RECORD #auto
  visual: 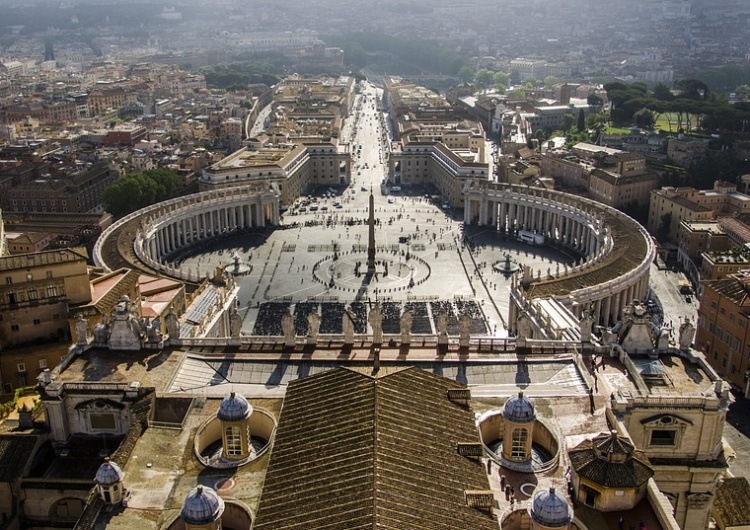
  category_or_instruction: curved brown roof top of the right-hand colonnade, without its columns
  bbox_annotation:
[466,182,656,299]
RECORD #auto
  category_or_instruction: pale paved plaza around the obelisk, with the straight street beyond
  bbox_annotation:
[178,85,575,337]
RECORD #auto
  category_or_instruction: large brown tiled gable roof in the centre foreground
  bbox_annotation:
[254,368,498,530]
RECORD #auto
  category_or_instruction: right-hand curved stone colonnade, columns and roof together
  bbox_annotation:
[464,182,656,333]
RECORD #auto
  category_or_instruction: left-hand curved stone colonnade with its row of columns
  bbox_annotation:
[94,187,279,282]
